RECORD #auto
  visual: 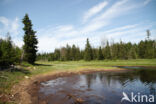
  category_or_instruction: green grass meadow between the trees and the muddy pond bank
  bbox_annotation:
[0,59,156,103]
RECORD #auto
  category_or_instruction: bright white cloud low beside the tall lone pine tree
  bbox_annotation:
[37,25,78,52]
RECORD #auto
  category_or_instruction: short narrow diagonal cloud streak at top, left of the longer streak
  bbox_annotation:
[83,1,108,22]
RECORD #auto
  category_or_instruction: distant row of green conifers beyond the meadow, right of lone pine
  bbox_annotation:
[37,33,156,61]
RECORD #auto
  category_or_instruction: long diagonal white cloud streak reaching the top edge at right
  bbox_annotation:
[82,0,152,34]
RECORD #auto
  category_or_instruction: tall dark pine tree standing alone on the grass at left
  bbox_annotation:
[22,14,38,64]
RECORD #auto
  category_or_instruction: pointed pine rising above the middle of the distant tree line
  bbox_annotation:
[84,38,93,61]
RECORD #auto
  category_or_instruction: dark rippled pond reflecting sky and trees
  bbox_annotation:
[39,68,156,104]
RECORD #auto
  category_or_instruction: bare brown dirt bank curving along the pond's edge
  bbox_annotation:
[12,68,128,104]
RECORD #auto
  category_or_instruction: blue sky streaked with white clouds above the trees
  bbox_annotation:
[0,0,156,53]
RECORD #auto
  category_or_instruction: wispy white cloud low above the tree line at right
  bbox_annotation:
[99,24,153,42]
